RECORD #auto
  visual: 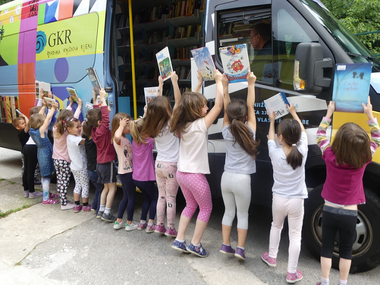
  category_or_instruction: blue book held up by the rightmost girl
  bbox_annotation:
[332,63,372,113]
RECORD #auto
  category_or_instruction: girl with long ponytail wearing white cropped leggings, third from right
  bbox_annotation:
[220,72,258,260]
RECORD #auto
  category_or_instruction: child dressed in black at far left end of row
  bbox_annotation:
[13,114,42,199]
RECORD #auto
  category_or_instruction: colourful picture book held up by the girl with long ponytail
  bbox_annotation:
[219,44,250,83]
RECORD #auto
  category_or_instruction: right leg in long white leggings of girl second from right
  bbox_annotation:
[288,199,304,273]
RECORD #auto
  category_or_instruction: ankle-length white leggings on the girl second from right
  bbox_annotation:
[269,195,304,273]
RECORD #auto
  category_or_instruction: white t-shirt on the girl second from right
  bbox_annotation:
[268,132,308,196]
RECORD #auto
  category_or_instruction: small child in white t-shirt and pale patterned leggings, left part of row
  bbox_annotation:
[64,117,91,213]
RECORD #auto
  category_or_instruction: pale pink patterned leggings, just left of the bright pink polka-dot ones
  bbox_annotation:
[156,161,178,229]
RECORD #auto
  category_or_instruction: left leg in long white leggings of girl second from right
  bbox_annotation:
[269,195,288,258]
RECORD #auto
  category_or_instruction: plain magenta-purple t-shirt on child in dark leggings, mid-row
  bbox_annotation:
[132,138,156,181]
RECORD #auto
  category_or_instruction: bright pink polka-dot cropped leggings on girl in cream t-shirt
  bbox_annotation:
[177,170,212,223]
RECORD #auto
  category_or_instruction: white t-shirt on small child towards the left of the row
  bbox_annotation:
[67,135,87,171]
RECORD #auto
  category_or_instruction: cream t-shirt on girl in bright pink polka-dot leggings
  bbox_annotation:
[177,118,210,174]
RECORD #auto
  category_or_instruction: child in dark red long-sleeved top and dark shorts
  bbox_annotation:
[87,89,117,223]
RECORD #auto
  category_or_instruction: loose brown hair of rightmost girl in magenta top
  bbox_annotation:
[331,123,372,168]
